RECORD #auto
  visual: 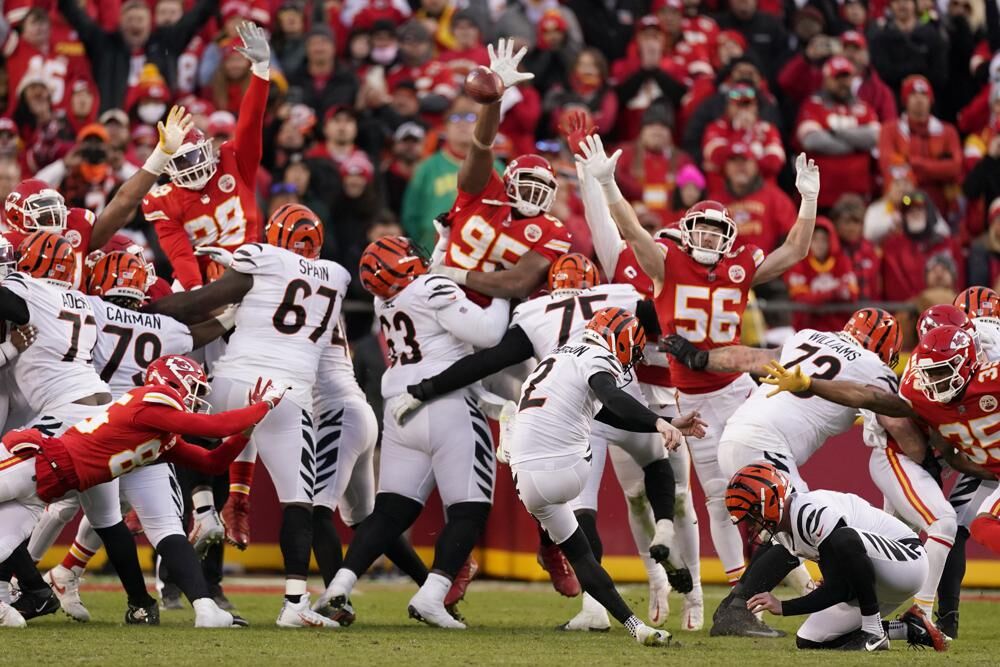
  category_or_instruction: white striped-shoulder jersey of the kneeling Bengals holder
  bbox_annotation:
[774,491,920,561]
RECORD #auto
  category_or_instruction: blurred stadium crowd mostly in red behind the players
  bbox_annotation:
[0,0,1000,386]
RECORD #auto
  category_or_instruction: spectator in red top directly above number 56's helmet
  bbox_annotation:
[708,143,798,253]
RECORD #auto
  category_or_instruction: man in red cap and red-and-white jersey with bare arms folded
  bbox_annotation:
[795,56,879,209]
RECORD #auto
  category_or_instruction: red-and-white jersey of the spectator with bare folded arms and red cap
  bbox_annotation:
[795,95,878,208]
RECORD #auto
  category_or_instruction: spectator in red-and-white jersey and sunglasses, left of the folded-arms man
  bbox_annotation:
[701,84,785,190]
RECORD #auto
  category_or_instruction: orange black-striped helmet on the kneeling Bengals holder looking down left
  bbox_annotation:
[726,463,791,542]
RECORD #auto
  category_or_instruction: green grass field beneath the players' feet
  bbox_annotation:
[0,580,1000,667]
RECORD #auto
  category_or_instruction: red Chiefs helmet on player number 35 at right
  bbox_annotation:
[910,325,979,403]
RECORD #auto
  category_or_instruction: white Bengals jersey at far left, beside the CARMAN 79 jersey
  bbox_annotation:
[2,273,108,414]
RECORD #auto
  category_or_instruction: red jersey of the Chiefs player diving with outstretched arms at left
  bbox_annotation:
[3,386,269,501]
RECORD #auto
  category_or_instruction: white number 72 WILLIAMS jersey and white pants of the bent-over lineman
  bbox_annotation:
[725,329,897,465]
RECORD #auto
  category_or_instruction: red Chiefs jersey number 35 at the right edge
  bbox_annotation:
[899,361,1000,474]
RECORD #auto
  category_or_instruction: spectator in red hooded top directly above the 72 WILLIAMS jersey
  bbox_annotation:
[785,216,858,331]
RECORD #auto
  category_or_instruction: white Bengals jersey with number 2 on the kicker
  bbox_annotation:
[507,337,624,465]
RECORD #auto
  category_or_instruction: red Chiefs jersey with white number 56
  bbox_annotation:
[656,242,764,394]
